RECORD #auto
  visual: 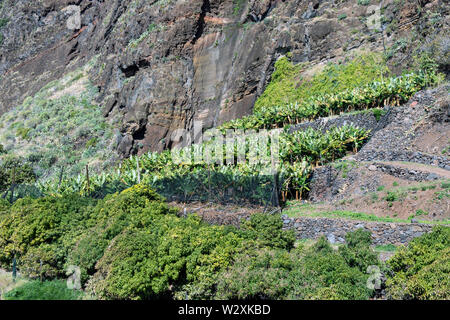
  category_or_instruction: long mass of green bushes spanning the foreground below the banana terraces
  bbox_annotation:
[0,185,377,299]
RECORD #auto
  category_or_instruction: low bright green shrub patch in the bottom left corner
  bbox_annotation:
[4,280,83,300]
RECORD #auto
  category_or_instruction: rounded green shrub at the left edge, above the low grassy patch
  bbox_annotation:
[0,195,95,278]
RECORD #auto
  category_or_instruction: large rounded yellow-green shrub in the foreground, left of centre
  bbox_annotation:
[89,215,243,299]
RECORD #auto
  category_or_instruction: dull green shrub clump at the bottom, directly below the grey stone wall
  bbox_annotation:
[216,237,372,299]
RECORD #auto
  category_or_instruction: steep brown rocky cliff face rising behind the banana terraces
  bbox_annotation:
[0,0,449,156]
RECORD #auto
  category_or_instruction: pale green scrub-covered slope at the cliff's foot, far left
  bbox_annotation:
[0,65,117,179]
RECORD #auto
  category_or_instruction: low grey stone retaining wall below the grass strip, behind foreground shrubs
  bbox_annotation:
[282,215,433,245]
